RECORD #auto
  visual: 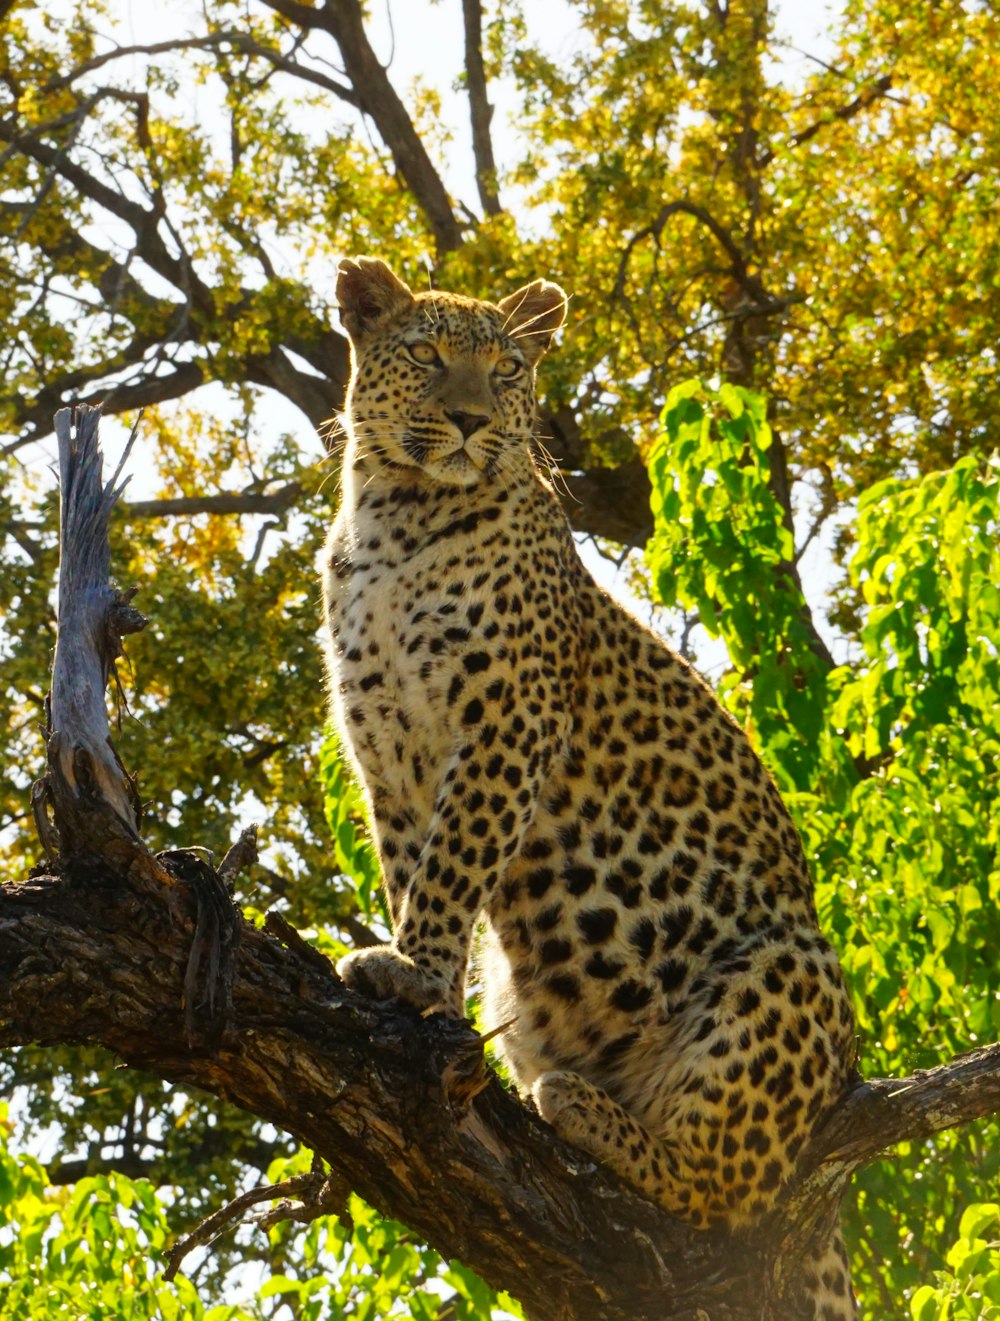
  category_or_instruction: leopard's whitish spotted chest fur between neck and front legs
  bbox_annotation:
[325,470,509,818]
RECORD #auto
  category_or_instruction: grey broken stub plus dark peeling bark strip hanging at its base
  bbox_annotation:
[32,404,241,1049]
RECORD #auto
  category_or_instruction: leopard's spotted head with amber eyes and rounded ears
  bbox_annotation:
[337,256,567,486]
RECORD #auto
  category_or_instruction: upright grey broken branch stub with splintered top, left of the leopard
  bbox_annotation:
[32,404,147,863]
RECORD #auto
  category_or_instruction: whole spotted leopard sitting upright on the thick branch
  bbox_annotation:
[321,256,857,1321]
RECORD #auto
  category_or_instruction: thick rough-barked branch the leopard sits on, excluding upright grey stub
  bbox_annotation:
[0,865,1000,1321]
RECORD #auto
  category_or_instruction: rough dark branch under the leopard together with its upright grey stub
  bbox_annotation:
[0,410,1000,1321]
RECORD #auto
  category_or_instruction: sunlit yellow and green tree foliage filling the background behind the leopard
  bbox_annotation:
[0,0,1000,1318]
